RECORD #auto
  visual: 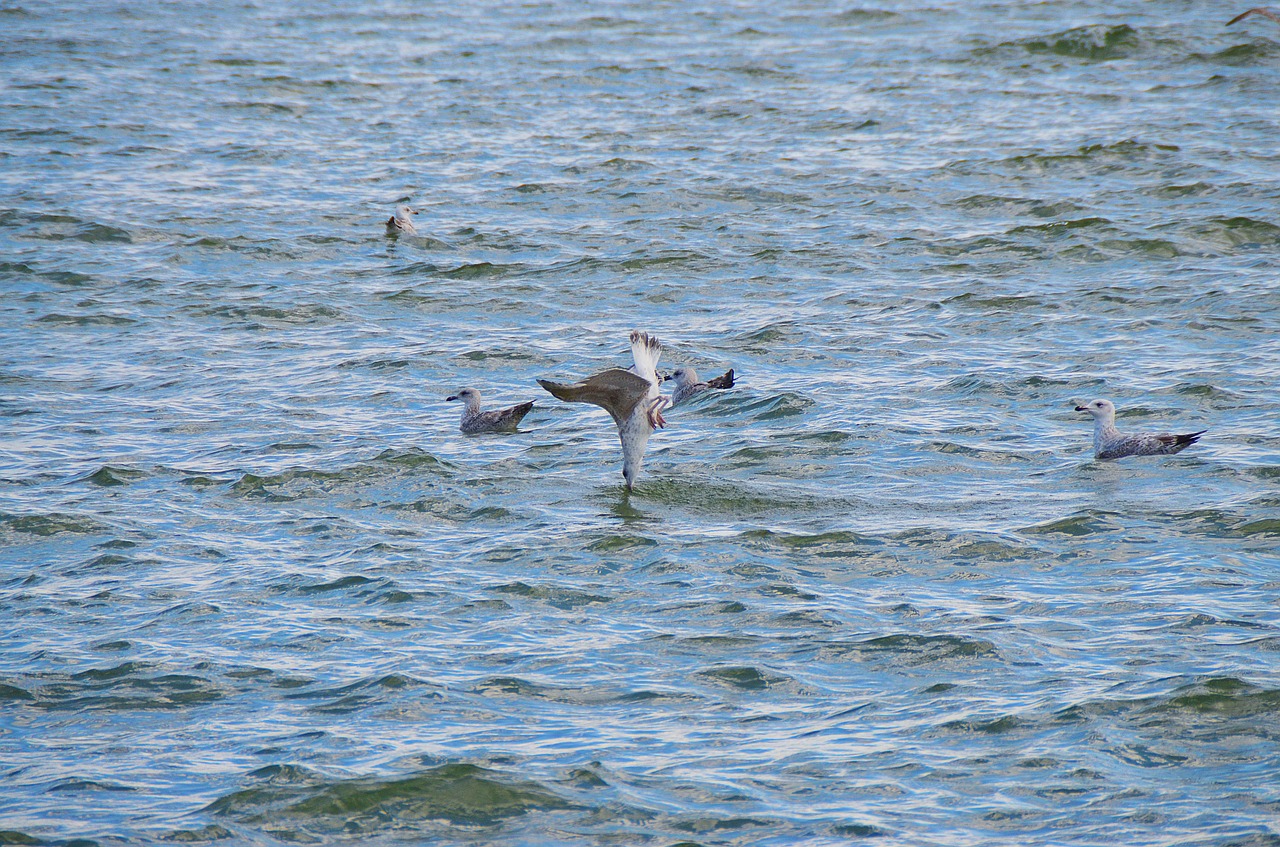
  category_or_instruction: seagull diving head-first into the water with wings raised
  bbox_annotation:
[538,330,669,491]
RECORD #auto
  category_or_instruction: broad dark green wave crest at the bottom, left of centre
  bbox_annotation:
[205,764,576,841]
